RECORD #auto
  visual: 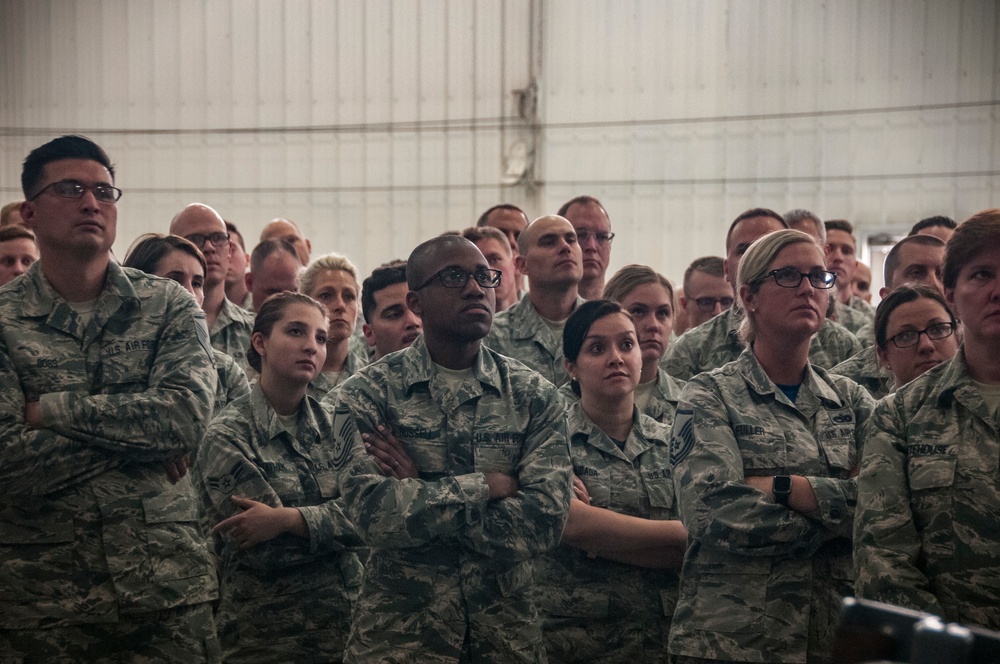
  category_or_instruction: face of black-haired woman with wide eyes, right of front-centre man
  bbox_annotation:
[566,313,642,398]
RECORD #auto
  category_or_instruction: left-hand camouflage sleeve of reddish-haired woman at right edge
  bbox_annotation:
[854,395,944,615]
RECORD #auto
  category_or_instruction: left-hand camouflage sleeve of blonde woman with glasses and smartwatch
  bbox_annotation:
[670,374,833,557]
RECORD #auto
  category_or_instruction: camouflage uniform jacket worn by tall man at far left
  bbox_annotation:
[0,263,217,629]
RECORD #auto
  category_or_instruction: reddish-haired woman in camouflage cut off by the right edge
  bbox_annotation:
[855,210,1000,630]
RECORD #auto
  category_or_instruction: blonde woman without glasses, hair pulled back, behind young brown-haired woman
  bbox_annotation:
[299,254,368,399]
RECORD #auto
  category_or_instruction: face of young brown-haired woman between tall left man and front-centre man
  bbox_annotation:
[250,302,328,386]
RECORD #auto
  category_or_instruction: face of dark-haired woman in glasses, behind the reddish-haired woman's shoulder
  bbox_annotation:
[877,297,958,387]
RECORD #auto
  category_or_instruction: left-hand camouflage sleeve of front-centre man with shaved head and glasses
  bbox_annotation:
[334,375,489,549]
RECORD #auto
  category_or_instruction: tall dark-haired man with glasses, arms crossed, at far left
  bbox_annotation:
[0,136,217,662]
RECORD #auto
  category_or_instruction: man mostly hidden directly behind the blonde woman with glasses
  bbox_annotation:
[660,208,861,380]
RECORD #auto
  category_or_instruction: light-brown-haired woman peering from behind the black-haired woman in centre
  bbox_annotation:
[604,265,684,426]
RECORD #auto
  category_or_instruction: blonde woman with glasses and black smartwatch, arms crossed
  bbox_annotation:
[670,230,874,662]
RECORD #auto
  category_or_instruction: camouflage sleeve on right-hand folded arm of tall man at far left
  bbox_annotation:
[39,291,217,461]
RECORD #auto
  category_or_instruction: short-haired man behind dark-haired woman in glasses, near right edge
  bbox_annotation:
[830,235,945,399]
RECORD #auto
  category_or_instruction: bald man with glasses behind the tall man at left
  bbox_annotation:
[170,203,253,361]
